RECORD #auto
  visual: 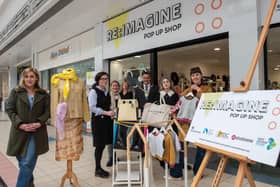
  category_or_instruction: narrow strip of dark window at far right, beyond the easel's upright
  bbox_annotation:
[266,27,280,89]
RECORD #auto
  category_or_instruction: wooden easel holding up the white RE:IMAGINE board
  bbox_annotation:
[191,0,277,187]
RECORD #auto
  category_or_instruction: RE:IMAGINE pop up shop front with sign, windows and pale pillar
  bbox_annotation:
[103,0,280,184]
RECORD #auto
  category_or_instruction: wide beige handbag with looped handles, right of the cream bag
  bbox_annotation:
[141,95,171,127]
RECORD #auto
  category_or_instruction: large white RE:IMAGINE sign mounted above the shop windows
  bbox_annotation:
[103,0,230,58]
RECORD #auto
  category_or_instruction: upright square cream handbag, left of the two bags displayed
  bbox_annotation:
[118,99,138,121]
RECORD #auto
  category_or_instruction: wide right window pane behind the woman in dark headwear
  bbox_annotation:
[158,39,229,93]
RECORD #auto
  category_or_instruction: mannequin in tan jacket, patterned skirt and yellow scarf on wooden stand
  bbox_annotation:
[51,68,90,186]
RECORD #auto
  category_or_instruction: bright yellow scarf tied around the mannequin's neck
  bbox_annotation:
[51,68,78,101]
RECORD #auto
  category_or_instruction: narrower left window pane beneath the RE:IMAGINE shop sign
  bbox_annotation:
[110,54,150,86]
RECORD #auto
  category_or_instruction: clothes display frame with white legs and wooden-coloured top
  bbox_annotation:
[126,119,188,187]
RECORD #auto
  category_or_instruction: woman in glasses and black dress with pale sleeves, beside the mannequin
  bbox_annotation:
[88,72,115,178]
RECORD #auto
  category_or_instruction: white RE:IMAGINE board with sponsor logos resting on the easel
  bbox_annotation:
[186,90,280,166]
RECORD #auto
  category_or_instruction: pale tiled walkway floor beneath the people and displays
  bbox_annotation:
[0,112,280,187]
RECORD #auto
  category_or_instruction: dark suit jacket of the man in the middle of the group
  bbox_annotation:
[134,85,159,110]
